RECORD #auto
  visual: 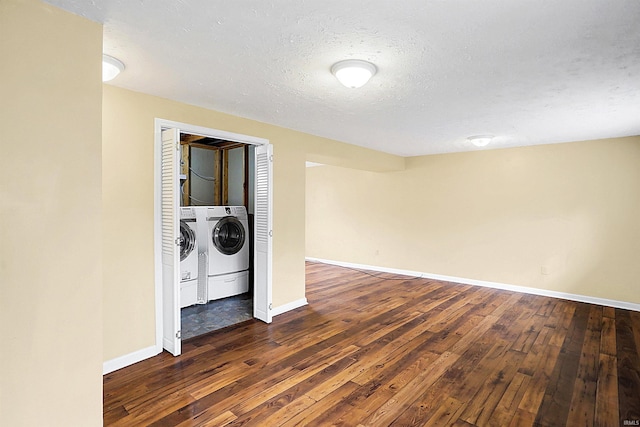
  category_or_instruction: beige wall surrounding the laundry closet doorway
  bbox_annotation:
[103,85,404,361]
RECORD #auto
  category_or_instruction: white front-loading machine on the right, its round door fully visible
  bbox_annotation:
[206,206,250,300]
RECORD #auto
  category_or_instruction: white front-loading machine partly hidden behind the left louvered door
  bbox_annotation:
[180,207,199,307]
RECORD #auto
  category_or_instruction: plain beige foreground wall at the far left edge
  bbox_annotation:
[0,0,102,427]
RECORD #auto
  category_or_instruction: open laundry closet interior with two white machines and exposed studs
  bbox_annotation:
[179,134,255,339]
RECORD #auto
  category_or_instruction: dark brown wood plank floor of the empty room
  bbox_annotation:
[104,263,640,427]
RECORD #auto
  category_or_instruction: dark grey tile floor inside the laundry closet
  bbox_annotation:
[180,293,253,340]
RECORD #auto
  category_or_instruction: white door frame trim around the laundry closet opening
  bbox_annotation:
[154,118,273,353]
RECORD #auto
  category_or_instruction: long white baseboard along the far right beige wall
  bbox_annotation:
[306,257,640,311]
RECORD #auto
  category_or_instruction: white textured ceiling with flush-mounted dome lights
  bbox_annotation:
[47,0,640,156]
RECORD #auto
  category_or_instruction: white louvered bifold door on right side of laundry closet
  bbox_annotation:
[253,144,273,323]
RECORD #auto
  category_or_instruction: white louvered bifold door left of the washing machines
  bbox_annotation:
[161,129,182,356]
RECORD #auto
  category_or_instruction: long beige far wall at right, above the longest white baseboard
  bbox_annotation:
[306,137,640,303]
